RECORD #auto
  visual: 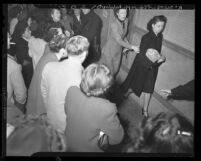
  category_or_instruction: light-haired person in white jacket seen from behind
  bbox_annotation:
[41,35,89,133]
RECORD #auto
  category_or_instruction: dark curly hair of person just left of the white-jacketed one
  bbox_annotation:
[49,34,67,53]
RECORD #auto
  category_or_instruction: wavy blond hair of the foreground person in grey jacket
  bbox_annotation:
[80,63,113,97]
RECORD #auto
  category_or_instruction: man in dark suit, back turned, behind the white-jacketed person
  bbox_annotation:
[80,9,102,67]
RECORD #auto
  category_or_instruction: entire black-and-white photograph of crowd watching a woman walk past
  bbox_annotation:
[1,3,195,157]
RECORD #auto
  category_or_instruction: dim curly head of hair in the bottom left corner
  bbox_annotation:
[7,115,67,156]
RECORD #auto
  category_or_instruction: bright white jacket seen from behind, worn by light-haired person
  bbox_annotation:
[41,57,83,133]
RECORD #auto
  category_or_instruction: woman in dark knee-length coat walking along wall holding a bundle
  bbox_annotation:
[122,15,167,117]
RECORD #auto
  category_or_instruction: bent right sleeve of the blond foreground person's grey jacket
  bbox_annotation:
[101,106,124,145]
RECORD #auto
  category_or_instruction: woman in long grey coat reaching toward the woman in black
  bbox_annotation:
[100,9,139,76]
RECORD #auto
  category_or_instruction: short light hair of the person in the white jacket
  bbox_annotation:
[66,35,89,56]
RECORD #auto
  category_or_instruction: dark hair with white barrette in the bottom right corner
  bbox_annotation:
[125,112,194,153]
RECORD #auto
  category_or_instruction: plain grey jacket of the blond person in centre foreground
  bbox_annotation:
[65,87,124,152]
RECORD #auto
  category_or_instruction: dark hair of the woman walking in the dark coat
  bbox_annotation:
[147,15,167,33]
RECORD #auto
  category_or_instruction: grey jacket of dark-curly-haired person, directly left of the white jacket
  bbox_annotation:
[26,46,58,115]
